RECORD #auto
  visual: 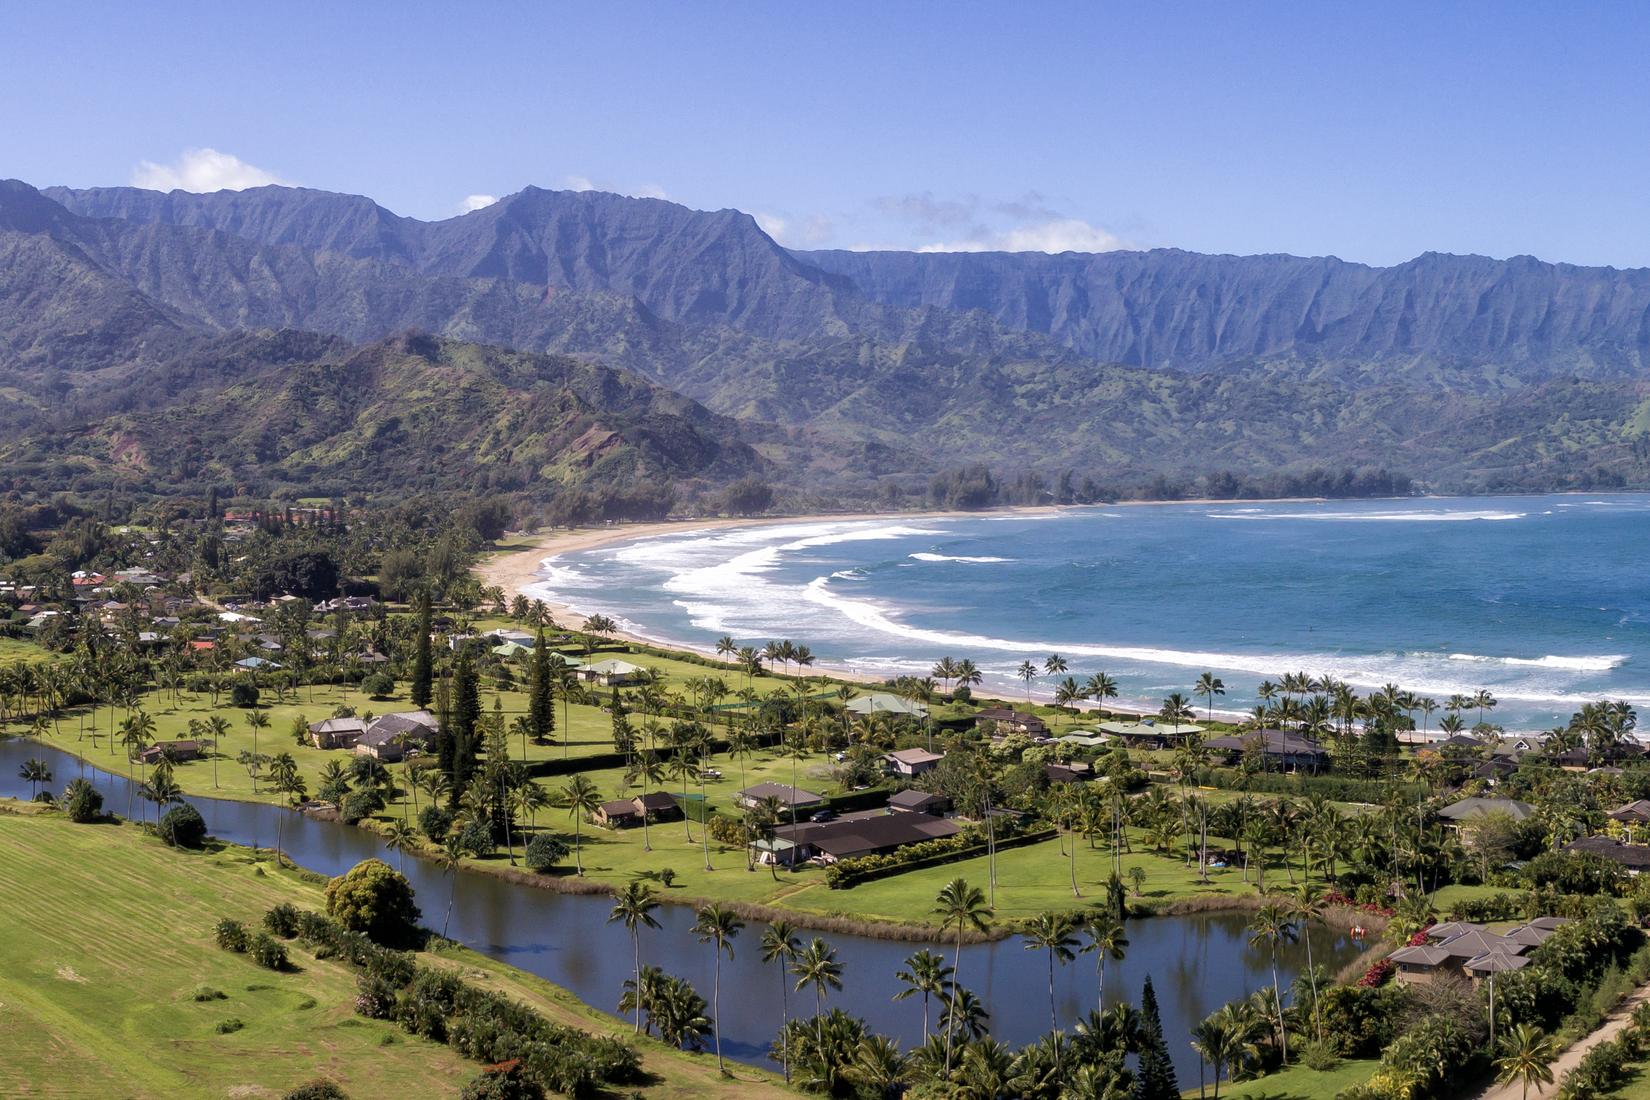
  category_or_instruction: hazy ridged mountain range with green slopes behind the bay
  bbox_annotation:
[0,181,1650,504]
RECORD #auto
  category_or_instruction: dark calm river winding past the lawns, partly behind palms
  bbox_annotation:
[0,739,1358,1087]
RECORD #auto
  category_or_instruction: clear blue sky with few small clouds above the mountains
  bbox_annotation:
[0,0,1650,267]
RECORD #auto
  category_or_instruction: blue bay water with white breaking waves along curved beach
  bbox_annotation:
[521,495,1650,731]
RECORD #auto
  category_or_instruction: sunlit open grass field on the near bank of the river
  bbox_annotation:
[0,803,784,1100]
